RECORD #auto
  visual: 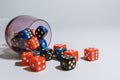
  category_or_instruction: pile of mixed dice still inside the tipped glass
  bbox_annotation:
[11,26,48,52]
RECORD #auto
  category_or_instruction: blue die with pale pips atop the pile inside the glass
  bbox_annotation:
[18,28,33,40]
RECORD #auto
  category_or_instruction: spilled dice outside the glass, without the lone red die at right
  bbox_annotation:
[22,44,79,72]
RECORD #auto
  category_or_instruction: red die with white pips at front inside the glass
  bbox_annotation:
[28,36,40,50]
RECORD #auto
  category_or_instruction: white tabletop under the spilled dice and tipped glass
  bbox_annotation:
[0,26,120,80]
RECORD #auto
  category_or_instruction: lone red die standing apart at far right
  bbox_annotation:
[84,48,99,61]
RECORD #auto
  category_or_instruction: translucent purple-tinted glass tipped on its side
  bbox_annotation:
[5,15,52,53]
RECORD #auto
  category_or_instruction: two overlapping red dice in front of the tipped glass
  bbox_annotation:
[22,51,46,72]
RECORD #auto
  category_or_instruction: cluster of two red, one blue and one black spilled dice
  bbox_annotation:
[53,44,79,70]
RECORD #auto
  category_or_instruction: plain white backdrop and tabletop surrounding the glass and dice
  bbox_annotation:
[0,0,120,80]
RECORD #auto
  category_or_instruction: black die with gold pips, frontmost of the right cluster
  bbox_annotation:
[60,55,76,70]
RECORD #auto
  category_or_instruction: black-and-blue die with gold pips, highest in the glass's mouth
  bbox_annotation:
[35,26,48,39]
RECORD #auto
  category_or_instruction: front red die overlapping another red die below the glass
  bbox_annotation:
[29,56,46,72]
